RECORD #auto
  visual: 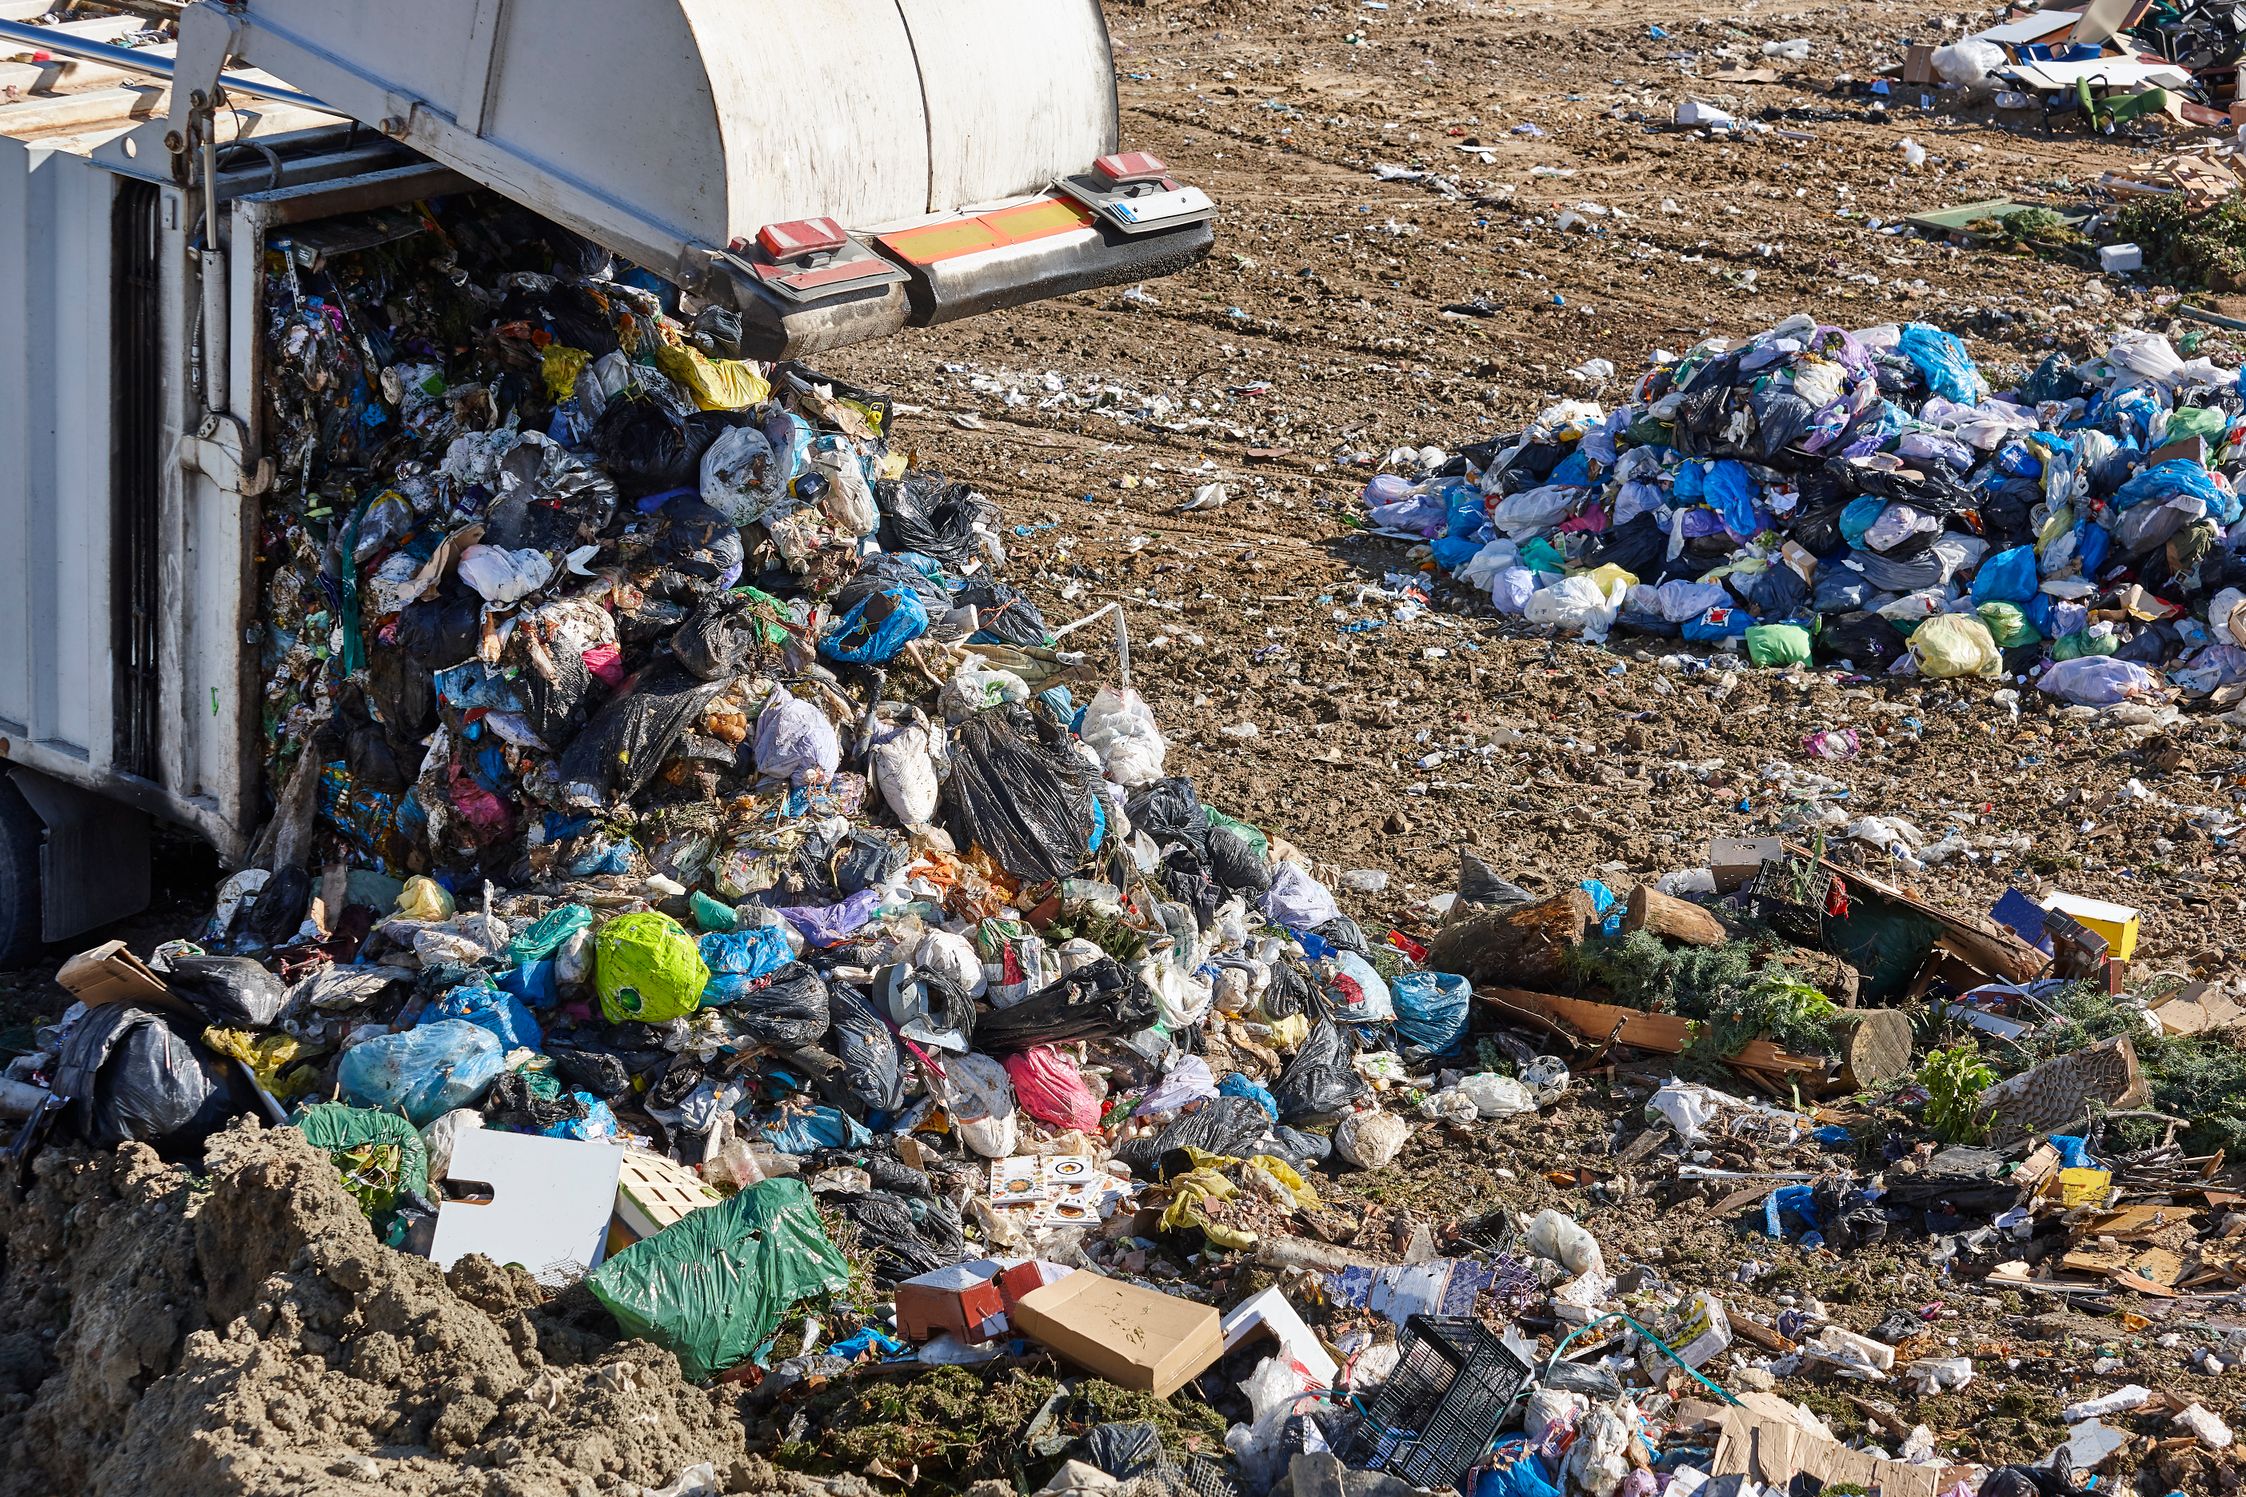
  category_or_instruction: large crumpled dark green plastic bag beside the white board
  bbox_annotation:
[586,1181,849,1383]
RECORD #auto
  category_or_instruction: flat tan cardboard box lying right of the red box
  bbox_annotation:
[1013,1270,1224,1398]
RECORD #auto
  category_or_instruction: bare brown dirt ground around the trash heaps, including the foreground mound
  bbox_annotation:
[0,0,2246,1497]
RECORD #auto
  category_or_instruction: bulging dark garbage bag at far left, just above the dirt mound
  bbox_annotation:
[54,1003,254,1158]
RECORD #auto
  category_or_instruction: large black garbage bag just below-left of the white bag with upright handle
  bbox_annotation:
[943,707,1098,882]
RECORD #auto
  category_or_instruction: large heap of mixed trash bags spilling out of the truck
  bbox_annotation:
[11,190,1565,1418]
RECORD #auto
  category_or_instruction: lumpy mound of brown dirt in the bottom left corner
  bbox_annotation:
[0,1124,790,1497]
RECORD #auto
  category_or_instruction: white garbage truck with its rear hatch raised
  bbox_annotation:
[0,0,1213,965]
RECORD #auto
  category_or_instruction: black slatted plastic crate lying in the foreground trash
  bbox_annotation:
[1334,1315,1532,1490]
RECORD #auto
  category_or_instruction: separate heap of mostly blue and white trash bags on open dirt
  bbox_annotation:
[1363,316,2246,707]
